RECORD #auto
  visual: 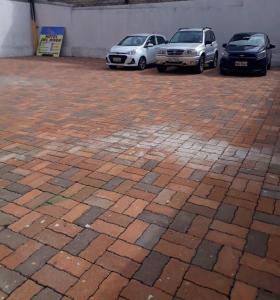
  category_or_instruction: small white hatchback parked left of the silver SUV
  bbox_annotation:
[106,33,166,70]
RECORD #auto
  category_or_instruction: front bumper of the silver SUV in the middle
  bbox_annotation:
[156,55,200,67]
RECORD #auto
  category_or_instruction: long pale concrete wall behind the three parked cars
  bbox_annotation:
[0,0,280,65]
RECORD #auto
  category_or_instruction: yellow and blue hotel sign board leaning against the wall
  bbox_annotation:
[37,27,64,57]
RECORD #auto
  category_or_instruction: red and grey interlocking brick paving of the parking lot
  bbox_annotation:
[0,58,280,300]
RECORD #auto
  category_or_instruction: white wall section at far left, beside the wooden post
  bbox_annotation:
[0,0,33,57]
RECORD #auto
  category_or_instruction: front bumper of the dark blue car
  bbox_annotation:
[220,57,267,73]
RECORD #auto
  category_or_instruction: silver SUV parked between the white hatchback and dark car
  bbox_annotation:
[156,27,218,73]
